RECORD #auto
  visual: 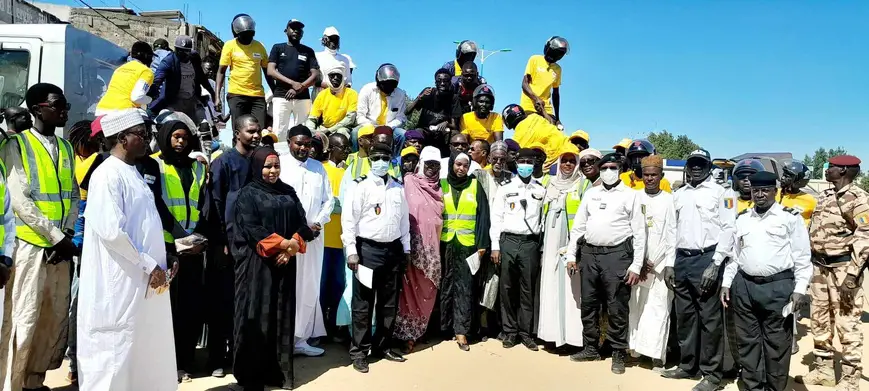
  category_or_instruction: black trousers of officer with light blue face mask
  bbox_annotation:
[498,233,540,338]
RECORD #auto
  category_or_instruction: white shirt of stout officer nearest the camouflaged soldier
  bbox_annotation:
[721,203,812,294]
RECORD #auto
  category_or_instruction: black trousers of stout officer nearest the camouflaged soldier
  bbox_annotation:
[730,269,794,391]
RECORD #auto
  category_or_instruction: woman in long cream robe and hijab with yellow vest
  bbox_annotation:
[537,143,590,347]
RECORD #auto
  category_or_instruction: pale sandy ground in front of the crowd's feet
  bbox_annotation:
[46,315,869,391]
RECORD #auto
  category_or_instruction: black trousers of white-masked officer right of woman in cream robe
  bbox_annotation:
[579,240,634,350]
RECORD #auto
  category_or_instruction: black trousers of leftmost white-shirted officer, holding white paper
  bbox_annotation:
[350,237,405,360]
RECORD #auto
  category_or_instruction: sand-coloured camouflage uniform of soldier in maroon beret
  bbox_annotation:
[803,184,869,390]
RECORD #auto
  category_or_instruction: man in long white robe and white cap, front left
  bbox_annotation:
[78,110,178,391]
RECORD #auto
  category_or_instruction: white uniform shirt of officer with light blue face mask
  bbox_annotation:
[489,176,546,251]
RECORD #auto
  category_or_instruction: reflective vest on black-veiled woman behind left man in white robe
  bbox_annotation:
[151,154,205,243]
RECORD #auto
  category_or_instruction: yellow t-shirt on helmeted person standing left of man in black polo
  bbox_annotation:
[220,39,269,96]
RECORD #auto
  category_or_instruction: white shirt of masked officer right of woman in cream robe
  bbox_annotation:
[567,183,646,274]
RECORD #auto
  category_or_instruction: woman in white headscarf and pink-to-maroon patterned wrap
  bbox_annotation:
[395,147,444,351]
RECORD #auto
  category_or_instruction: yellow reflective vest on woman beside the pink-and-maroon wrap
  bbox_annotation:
[441,179,477,246]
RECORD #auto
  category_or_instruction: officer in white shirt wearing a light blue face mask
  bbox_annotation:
[489,148,546,350]
